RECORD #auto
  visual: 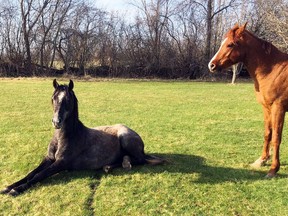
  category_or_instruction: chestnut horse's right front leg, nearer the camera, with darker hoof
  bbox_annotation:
[266,102,285,178]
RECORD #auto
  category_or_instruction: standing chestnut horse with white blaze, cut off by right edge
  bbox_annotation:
[208,23,288,177]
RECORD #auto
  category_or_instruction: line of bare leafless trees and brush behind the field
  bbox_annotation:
[0,0,288,79]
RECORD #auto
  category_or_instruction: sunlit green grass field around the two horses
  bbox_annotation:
[0,79,288,216]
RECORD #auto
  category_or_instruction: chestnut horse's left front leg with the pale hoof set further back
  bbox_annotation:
[251,106,272,168]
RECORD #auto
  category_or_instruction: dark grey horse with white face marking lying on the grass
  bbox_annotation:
[2,80,164,196]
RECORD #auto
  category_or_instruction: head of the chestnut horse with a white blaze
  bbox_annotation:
[208,23,247,72]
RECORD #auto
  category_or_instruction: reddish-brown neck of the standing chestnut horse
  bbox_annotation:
[243,31,288,82]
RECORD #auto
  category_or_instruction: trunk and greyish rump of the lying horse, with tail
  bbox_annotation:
[77,124,164,169]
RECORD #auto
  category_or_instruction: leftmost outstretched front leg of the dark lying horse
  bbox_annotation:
[0,157,54,194]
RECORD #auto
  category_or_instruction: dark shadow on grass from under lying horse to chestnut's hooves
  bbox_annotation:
[34,154,288,191]
